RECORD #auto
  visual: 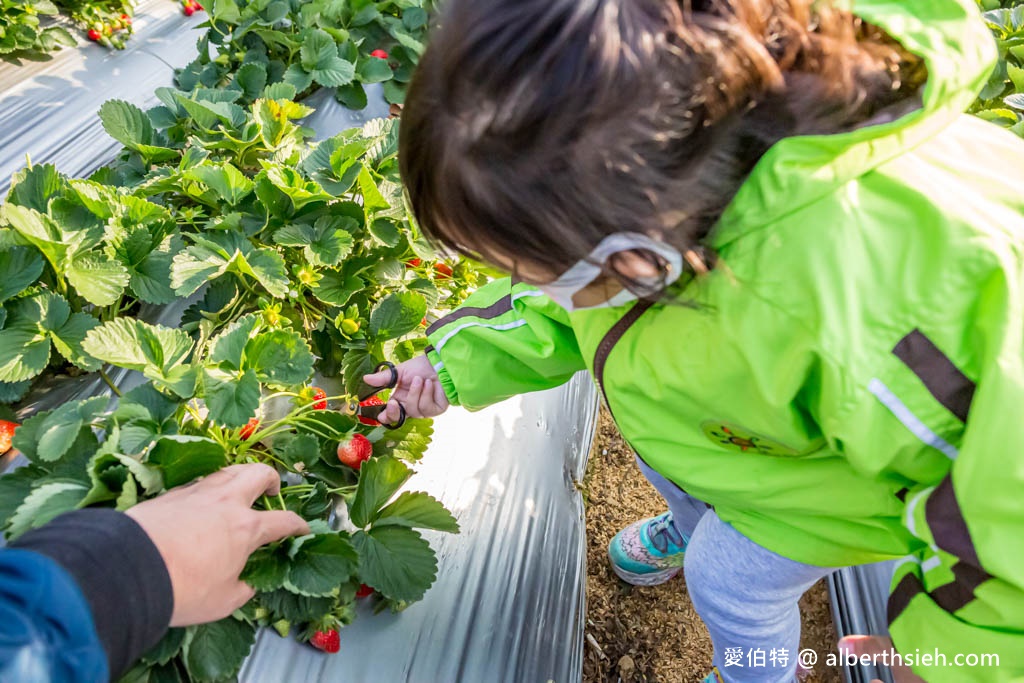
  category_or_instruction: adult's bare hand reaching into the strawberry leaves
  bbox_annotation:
[126,464,309,626]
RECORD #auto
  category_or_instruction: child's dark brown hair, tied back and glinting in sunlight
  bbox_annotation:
[400,0,923,274]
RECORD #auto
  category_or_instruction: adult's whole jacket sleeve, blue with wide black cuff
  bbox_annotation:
[6,509,174,683]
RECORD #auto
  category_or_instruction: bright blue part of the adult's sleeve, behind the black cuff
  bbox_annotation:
[0,549,108,683]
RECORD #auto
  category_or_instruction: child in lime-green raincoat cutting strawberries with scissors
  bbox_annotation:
[368,0,1024,683]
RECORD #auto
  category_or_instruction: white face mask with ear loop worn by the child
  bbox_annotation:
[538,232,683,311]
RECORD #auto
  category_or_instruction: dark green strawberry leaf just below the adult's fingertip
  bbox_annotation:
[286,533,359,597]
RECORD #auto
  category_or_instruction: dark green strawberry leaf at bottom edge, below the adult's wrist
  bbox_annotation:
[184,618,256,683]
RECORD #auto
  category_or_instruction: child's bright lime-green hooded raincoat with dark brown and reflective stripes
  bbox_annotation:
[428,0,1024,683]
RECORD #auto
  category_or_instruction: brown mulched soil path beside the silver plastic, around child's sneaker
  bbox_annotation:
[583,411,842,683]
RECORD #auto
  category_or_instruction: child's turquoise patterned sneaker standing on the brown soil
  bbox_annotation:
[608,512,687,586]
